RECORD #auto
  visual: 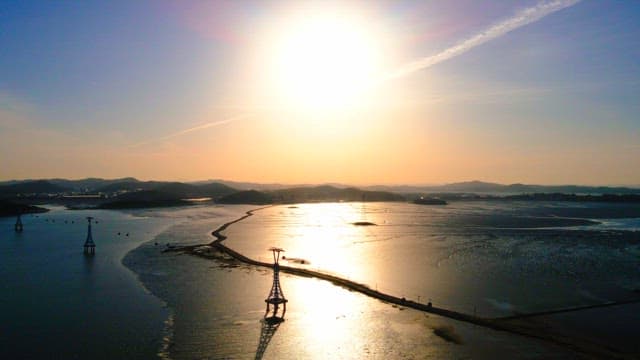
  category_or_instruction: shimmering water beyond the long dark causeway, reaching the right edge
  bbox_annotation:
[227,202,640,317]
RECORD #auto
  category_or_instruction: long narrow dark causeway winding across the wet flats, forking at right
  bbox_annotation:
[169,206,640,358]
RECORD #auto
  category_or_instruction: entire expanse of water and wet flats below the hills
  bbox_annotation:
[0,201,640,359]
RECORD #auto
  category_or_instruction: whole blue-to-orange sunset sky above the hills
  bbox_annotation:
[0,0,640,185]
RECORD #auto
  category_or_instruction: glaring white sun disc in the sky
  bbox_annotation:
[271,12,380,110]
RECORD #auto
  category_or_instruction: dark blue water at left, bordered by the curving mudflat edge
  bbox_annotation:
[0,208,173,359]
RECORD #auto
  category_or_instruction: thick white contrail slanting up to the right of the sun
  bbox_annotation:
[384,0,580,80]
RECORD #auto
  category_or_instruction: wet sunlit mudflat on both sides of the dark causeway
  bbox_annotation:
[132,203,638,358]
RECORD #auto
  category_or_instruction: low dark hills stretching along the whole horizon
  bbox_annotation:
[0,177,640,213]
